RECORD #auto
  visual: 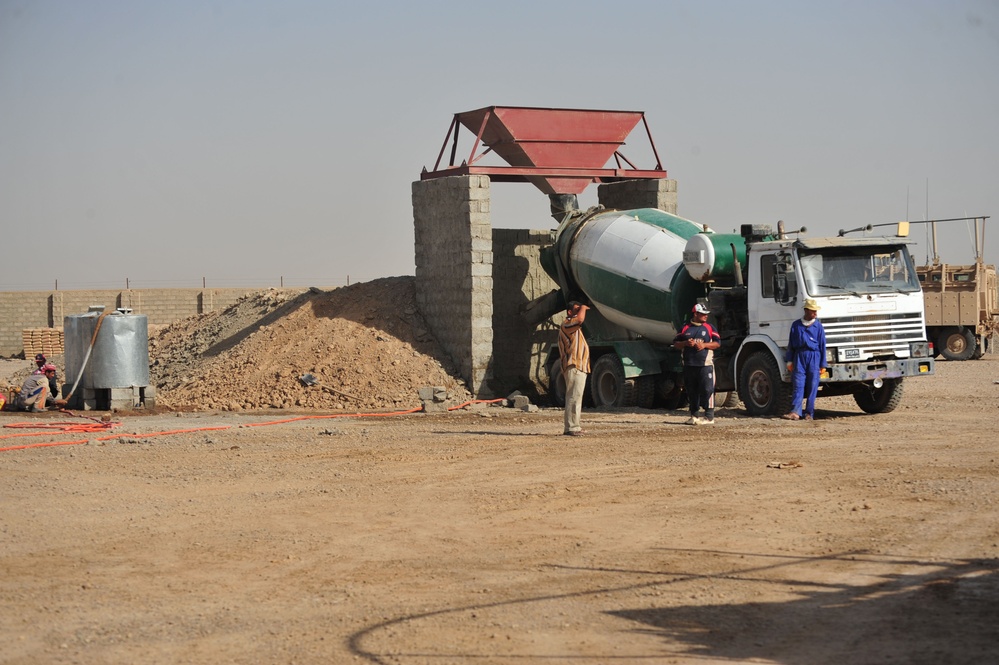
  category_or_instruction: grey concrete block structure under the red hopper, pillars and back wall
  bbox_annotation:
[413,176,677,397]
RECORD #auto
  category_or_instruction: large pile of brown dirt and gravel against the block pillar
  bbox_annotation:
[149,277,470,411]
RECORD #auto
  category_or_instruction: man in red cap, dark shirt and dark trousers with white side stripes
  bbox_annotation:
[673,303,721,425]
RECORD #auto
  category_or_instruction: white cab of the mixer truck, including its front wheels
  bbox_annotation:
[729,238,934,415]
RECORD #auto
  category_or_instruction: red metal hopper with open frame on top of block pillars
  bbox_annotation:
[420,106,666,194]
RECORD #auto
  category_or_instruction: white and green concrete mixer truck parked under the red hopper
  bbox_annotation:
[539,207,934,416]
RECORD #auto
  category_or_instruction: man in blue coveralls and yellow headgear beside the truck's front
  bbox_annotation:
[781,298,826,420]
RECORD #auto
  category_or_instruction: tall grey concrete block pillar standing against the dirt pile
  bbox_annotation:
[412,175,493,397]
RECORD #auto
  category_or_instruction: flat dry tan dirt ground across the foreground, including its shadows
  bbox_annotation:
[0,356,999,665]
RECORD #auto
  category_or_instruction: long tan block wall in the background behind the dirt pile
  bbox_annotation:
[0,288,301,357]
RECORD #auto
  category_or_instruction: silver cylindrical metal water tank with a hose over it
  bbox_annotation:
[63,308,153,411]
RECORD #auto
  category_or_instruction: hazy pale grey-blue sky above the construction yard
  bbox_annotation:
[0,0,999,290]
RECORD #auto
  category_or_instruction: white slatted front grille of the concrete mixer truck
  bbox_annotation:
[822,312,926,358]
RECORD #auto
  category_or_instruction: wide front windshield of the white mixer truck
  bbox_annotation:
[798,247,919,296]
